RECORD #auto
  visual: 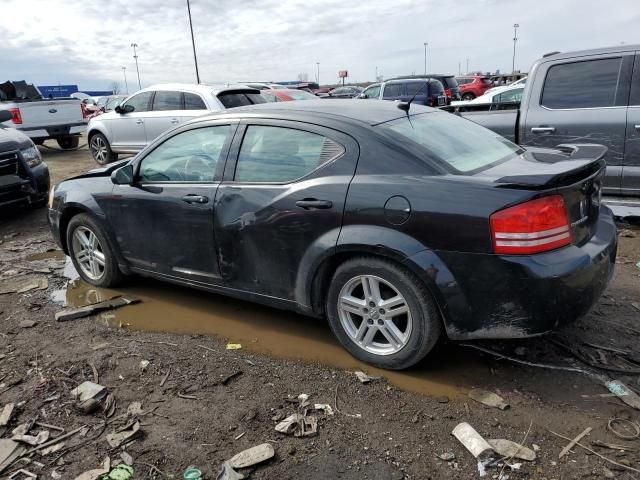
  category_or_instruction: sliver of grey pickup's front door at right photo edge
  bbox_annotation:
[621,52,640,196]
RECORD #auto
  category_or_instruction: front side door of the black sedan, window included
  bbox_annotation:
[106,121,237,284]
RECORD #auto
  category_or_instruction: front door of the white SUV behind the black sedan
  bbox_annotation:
[109,92,153,151]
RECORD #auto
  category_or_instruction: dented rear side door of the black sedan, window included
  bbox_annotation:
[215,120,359,300]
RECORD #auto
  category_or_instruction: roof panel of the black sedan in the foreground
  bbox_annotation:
[189,99,437,125]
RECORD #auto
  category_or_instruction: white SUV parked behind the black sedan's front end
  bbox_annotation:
[87,84,265,165]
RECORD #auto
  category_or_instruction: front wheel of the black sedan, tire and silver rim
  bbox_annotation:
[66,213,124,287]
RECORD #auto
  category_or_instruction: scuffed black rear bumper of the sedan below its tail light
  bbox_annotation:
[412,207,617,340]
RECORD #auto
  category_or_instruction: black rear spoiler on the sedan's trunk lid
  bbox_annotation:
[495,144,608,188]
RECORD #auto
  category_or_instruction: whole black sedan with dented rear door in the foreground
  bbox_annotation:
[49,100,616,369]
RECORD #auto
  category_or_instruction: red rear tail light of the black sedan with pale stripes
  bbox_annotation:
[489,195,571,255]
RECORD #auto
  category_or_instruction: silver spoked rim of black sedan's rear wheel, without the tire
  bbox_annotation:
[338,275,412,355]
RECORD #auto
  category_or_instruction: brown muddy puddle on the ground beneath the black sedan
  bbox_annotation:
[52,262,487,398]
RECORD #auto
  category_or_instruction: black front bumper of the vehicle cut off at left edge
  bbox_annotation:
[0,163,50,207]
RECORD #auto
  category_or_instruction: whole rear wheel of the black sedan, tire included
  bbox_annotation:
[326,257,442,370]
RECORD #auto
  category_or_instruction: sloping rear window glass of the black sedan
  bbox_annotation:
[378,112,523,174]
